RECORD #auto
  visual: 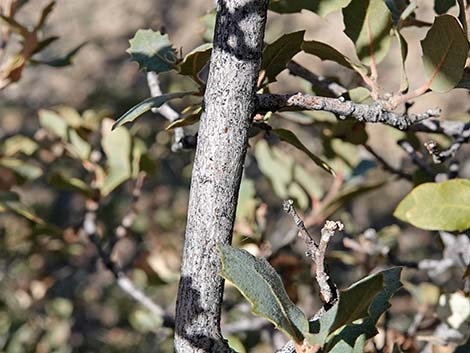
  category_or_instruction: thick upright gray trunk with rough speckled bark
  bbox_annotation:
[175,0,268,353]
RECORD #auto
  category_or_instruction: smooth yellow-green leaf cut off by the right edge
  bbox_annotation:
[393,179,470,231]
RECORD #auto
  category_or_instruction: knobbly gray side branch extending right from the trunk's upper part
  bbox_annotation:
[258,92,440,130]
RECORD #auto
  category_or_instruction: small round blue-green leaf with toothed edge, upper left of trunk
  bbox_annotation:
[127,29,177,73]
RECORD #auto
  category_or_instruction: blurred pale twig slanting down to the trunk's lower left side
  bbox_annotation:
[82,200,174,327]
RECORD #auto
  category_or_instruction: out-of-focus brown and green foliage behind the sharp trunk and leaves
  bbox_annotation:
[0,0,470,353]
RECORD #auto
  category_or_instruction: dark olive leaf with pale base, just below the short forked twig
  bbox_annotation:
[308,272,384,345]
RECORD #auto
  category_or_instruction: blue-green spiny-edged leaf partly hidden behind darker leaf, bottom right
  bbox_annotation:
[325,267,402,353]
